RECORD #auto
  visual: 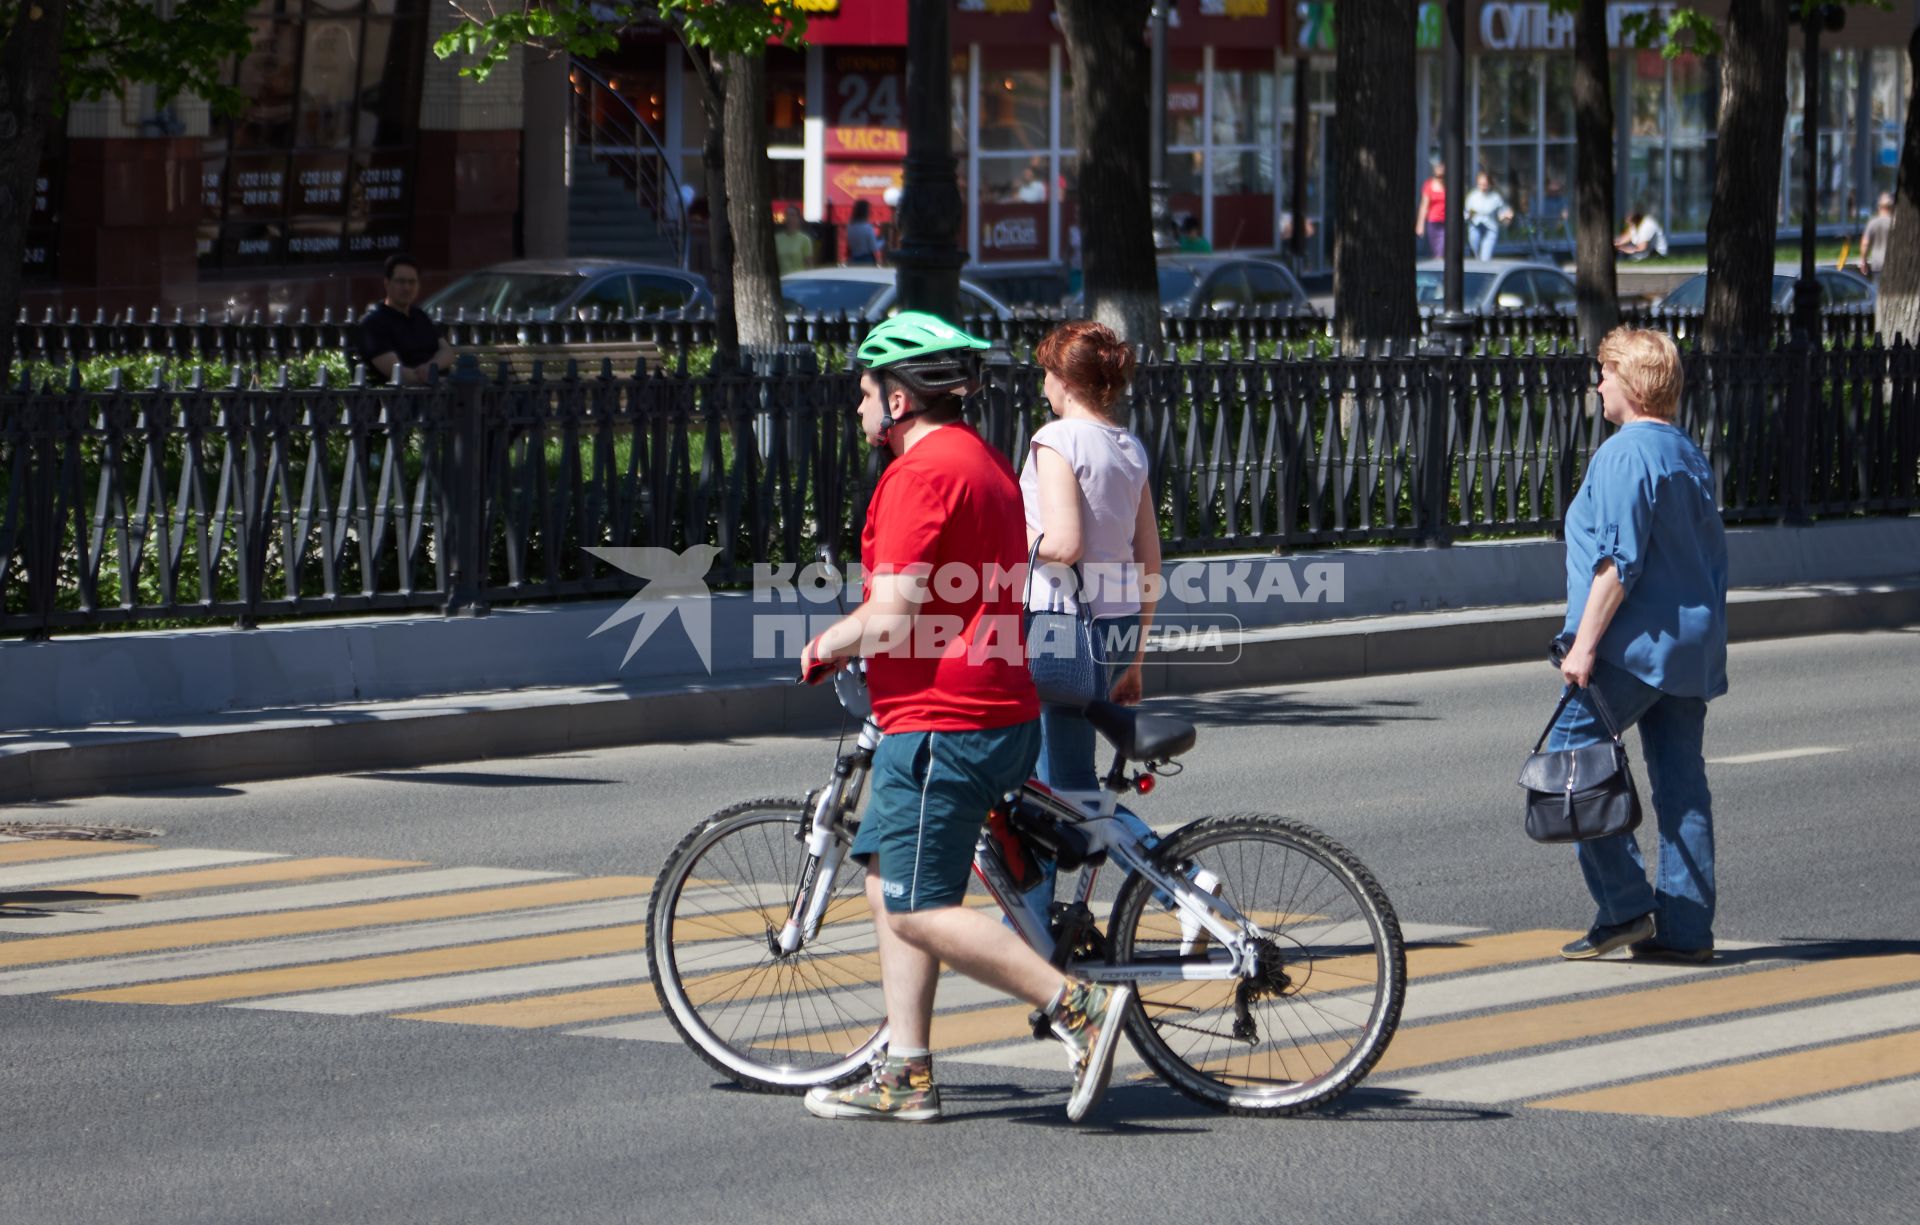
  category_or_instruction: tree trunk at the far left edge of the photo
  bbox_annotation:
[0,0,67,384]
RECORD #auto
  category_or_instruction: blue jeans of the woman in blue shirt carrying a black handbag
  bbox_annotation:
[1546,662,1715,949]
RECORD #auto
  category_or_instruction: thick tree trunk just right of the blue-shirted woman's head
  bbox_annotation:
[1705,0,1793,349]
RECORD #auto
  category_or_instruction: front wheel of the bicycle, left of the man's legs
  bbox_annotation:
[647,799,887,1093]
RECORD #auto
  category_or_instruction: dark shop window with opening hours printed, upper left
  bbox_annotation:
[198,10,424,269]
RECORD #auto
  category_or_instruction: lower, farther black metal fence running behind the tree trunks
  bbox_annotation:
[15,307,1874,365]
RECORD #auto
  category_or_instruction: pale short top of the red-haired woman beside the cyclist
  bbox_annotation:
[1020,419,1146,616]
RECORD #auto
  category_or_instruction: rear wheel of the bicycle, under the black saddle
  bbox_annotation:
[1108,812,1407,1116]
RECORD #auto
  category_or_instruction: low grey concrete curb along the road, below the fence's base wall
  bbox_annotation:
[0,576,1920,803]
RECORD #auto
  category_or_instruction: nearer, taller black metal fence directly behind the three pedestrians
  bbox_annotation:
[0,346,1920,634]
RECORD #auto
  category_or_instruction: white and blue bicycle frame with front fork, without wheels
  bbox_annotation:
[778,718,1261,983]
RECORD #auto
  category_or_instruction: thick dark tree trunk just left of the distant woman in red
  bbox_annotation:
[1332,0,1428,348]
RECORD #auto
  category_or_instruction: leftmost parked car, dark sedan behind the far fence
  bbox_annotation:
[420,259,714,319]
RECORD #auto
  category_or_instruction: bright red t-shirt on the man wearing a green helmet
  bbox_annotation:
[860,424,1041,732]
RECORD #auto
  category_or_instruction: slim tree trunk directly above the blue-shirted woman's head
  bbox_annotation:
[1572,0,1620,353]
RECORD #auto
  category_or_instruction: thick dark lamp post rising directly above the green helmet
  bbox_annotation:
[893,0,966,319]
